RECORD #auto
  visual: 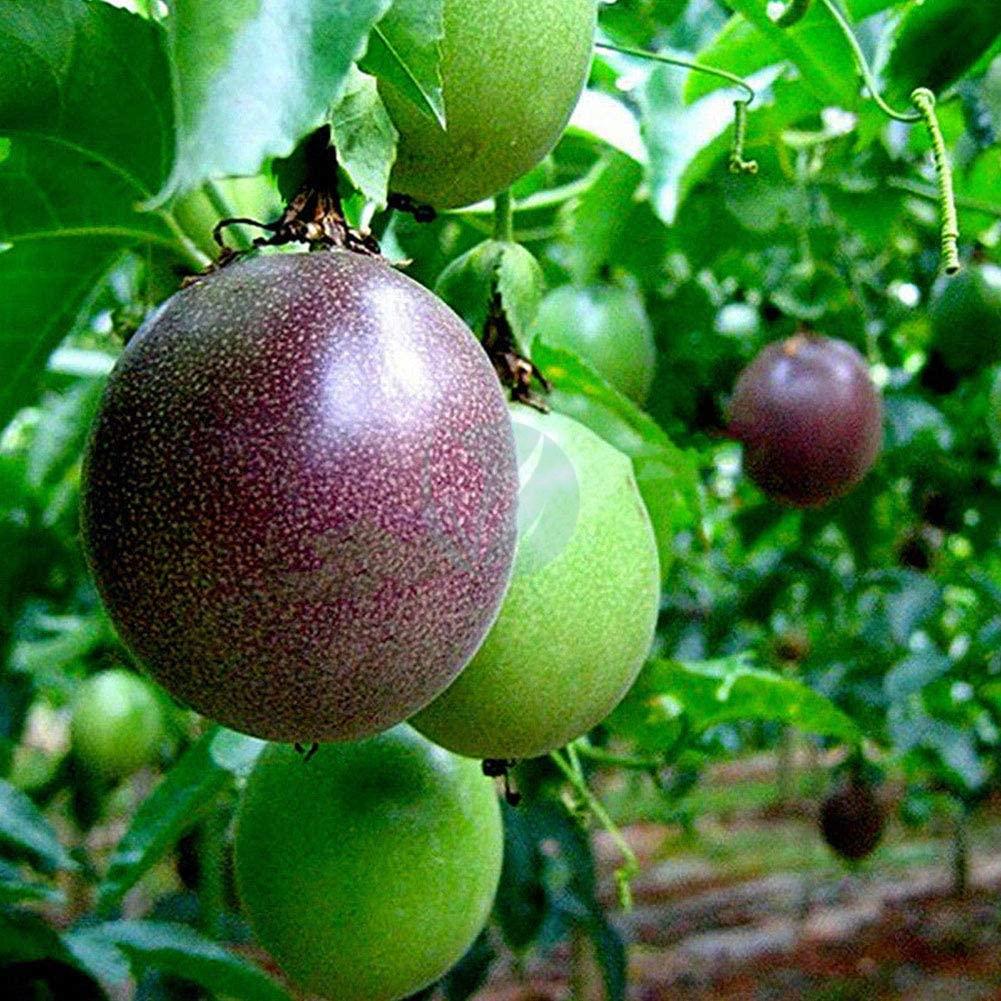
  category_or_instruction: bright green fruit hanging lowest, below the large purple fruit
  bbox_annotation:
[235,727,504,1001]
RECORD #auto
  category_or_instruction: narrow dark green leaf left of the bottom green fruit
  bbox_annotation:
[96,727,263,914]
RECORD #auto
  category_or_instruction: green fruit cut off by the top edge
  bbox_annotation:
[379,0,598,208]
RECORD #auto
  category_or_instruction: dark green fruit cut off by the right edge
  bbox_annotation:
[931,264,1001,373]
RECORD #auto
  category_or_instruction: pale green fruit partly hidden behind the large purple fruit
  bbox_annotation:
[412,406,660,758]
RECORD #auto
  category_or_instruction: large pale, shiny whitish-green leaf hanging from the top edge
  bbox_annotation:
[158,0,390,201]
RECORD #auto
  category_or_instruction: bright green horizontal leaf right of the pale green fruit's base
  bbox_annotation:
[617,654,862,749]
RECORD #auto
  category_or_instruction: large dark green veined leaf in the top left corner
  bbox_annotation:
[0,0,185,426]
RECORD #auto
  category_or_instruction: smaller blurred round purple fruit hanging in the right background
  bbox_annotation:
[730,333,883,508]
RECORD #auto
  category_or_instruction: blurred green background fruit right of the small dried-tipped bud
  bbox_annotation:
[533,285,657,405]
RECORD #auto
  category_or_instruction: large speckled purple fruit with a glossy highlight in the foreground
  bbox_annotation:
[82,251,518,741]
